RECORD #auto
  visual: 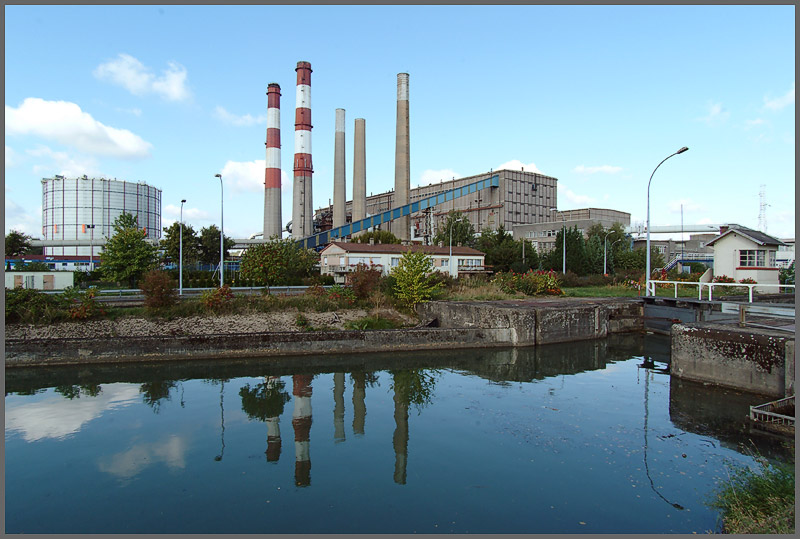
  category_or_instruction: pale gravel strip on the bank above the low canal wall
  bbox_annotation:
[5,309,414,340]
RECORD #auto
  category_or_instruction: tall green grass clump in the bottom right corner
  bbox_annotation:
[710,447,795,534]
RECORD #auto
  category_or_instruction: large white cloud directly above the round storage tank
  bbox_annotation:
[6,97,152,159]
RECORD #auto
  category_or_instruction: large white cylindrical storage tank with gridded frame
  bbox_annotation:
[42,175,161,256]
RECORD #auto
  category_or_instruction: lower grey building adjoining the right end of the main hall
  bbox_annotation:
[513,209,631,253]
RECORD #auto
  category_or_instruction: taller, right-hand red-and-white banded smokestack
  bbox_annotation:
[292,62,314,238]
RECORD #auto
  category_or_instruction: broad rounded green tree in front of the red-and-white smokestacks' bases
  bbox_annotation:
[241,235,319,286]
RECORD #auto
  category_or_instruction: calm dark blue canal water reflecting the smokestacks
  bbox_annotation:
[5,336,792,534]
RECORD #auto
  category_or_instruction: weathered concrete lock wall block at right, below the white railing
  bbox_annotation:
[670,322,794,397]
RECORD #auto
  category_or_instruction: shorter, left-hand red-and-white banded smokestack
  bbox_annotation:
[263,82,283,240]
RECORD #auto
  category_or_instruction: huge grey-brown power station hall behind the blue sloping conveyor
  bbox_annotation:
[314,170,560,244]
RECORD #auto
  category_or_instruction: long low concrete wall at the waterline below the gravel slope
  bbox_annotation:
[5,328,511,369]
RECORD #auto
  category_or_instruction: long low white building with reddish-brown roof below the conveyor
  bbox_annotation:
[320,241,485,283]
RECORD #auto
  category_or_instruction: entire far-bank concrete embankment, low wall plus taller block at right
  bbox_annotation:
[5,298,642,368]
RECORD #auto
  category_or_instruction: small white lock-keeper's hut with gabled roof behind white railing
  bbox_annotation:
[707,225,783,292]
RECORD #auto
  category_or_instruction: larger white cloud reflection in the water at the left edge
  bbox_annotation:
[6,384,139,442]
